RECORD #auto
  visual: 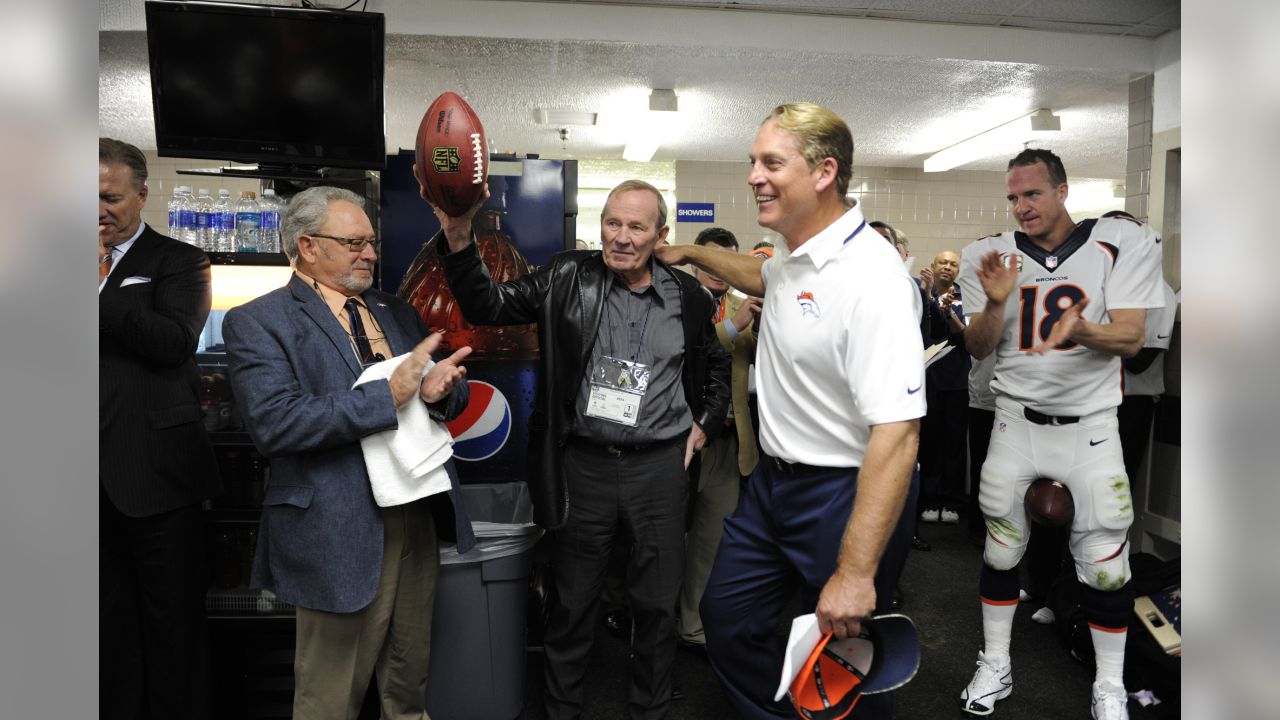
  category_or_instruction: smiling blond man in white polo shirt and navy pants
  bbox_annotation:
[658,104,924,720]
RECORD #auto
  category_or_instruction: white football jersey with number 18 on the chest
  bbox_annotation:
[959,218,1165,416]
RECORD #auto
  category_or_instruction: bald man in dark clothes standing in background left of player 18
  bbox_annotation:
[920,250,969,523]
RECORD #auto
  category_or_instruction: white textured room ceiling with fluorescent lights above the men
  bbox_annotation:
[99,0,1180,178]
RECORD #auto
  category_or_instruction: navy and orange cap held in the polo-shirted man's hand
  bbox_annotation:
[788,615,920,720]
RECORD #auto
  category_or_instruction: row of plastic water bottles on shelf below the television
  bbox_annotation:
[169,184,284,252]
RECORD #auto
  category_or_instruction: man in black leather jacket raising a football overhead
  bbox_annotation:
[424,181,730,720]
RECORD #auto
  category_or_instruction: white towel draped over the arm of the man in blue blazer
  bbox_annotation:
[352,352,453,507]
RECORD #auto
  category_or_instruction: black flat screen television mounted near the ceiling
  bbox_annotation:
[146,0,387,169]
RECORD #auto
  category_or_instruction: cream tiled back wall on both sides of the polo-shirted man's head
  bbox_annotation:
[672,161,1015,266]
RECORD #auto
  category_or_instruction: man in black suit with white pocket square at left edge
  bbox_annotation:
[97,137,219,720]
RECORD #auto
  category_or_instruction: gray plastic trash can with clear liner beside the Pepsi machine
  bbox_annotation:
[426,483,543,720]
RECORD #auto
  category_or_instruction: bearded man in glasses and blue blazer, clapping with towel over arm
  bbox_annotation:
[223,187,475,720]
